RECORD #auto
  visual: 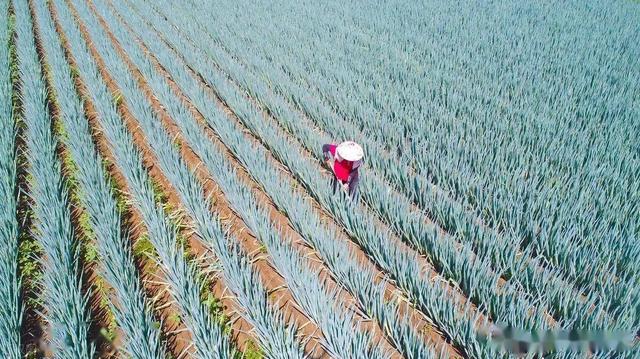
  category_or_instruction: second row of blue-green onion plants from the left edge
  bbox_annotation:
[13,1,95,358]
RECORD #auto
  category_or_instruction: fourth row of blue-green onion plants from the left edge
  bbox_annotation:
[54,1,233,358]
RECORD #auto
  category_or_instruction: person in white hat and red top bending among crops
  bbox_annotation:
[322,141,364,199]
